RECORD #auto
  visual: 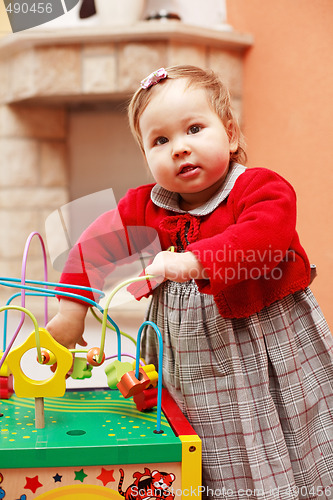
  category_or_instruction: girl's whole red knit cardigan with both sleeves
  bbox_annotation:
[60,168,310,318]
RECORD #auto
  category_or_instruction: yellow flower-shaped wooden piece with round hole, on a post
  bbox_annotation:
[7,328,73,398]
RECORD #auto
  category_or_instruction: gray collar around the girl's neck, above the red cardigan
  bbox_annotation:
[150,163,246,216]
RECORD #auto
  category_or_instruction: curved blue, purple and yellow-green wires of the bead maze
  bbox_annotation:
[0,232,163,433]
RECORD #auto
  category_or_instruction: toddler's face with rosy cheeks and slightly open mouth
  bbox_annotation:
[140,78,238,210]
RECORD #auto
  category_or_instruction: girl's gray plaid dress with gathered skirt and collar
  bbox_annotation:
[143,167,333,500]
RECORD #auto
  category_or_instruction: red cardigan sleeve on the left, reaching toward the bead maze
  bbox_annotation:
[58,185,158,300]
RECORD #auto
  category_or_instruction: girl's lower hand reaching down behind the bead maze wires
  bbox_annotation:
[46,299,88,349]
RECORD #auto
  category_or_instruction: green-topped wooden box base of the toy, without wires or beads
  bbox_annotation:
[0,389,201,500]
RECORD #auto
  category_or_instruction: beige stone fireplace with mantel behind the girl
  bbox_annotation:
[0,21,252,312]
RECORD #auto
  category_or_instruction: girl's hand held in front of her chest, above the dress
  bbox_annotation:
[145,251,207,283]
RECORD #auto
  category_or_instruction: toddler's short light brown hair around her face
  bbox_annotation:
[128,65,247,164]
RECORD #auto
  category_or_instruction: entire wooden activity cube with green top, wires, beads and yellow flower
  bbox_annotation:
[0,233,203,500]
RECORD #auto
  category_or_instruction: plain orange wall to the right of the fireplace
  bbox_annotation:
[227,0,333,330]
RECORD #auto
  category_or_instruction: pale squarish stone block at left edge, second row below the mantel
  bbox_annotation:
[0,138,39,187]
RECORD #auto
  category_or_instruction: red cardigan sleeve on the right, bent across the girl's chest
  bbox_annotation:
[187,168,298,295]
